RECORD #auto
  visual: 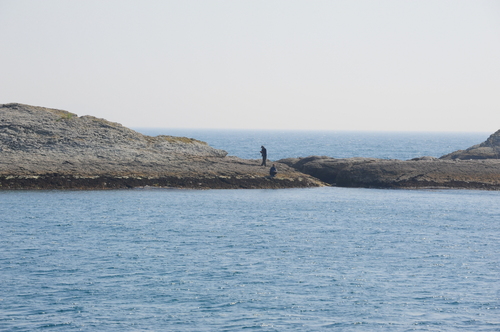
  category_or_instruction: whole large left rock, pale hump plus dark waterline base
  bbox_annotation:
[0,104,322,189]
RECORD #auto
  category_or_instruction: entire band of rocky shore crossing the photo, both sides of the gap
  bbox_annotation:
[0,104,500,190]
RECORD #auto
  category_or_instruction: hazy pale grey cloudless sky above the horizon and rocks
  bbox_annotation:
[0,0,500,132]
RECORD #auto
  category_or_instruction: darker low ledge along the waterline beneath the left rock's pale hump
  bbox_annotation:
[0,156,325,189]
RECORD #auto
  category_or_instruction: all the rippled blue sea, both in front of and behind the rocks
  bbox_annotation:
[0,128,500,331]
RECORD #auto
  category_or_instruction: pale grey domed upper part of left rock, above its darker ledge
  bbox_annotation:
[0,104,227,160]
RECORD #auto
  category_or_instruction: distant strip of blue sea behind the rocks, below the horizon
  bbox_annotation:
[137,128,492,160]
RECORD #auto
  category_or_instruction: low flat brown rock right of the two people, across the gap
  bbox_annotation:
[280,156,500,190]
